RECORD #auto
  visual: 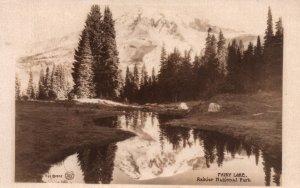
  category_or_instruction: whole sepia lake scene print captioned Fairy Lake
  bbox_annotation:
[1,0,298,186]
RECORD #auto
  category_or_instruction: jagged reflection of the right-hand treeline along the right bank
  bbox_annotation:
[158,113,282,185]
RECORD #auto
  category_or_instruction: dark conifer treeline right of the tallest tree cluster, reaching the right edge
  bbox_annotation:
[123,8,283,103]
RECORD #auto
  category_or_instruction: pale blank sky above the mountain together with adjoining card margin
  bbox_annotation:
[0,0,287,55]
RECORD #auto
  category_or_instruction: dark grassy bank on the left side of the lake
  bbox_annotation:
[15,102,134,182]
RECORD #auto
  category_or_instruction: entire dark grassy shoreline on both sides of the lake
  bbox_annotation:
[15,93,282,182]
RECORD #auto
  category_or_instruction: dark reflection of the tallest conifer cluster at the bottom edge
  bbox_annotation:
[78,143,117,184]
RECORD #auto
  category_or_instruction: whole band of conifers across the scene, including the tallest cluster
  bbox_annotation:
[15,5,283,103]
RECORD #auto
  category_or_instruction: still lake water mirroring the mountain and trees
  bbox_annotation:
[42,111,281,185]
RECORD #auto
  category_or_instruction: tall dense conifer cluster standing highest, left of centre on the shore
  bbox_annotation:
[72,5,120,99]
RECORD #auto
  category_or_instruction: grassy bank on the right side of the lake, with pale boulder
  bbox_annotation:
[159,93,282,158]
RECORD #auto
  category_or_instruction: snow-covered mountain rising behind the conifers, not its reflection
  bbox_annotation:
[17,7,256,90]
